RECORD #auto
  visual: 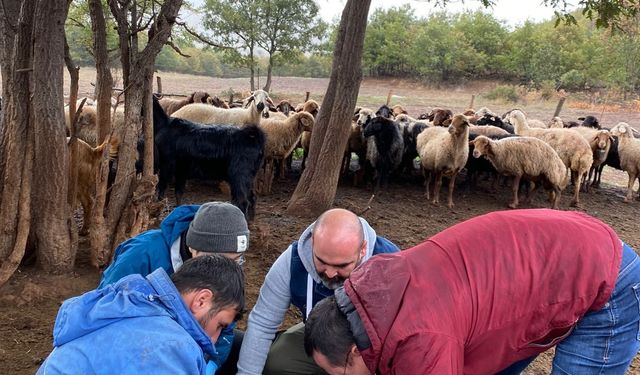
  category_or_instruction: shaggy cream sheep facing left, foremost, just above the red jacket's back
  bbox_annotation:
[472,135,567,209]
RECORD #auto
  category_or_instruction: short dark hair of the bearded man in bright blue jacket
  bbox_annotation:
[171,254,245,313]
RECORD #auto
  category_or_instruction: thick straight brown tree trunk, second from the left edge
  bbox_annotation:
[31,0,75,273]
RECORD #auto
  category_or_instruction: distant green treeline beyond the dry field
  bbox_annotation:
[67,5,640,92]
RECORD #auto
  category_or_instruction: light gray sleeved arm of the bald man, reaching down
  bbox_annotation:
[238,247,291,375]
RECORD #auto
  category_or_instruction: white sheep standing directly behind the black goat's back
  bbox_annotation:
[173,90,270,126]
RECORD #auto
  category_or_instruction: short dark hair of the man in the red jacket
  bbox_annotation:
[304,296,356,367]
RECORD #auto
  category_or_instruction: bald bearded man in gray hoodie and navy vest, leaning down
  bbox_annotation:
[238,208,400,375]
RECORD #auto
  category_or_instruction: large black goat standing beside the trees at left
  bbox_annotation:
[153,98,266,220]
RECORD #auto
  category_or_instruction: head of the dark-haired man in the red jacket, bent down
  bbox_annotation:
[304,297,371,375]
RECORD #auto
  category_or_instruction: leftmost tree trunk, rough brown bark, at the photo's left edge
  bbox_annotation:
[0,1,34,285]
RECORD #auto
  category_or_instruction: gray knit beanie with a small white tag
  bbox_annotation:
[187,202,249,253]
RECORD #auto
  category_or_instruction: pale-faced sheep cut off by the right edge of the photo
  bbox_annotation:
[611,122,640,202]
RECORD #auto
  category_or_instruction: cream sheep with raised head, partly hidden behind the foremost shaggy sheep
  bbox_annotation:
[508,110,593,206]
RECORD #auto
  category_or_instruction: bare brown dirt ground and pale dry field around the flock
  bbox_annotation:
[0,69,640,375]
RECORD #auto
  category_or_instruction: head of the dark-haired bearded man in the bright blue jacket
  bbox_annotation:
[171,254,244,342]
